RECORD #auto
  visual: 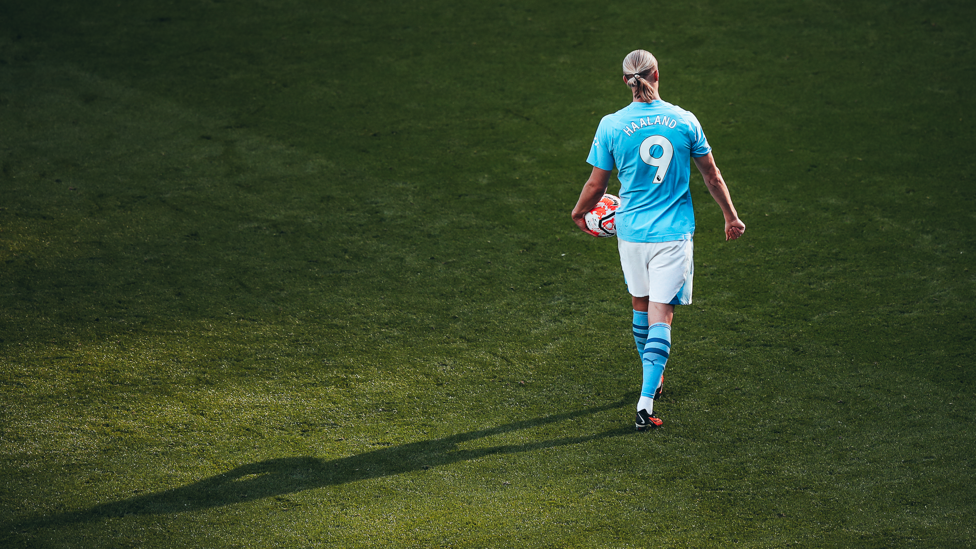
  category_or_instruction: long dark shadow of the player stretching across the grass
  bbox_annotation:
[6,401,633,531]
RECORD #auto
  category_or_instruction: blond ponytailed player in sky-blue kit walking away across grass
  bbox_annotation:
[572,50,746,431]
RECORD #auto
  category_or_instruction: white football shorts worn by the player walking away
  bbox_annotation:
[617,238,695,305]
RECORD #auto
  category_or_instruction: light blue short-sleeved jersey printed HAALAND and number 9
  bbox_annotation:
[586,100,712,242]
